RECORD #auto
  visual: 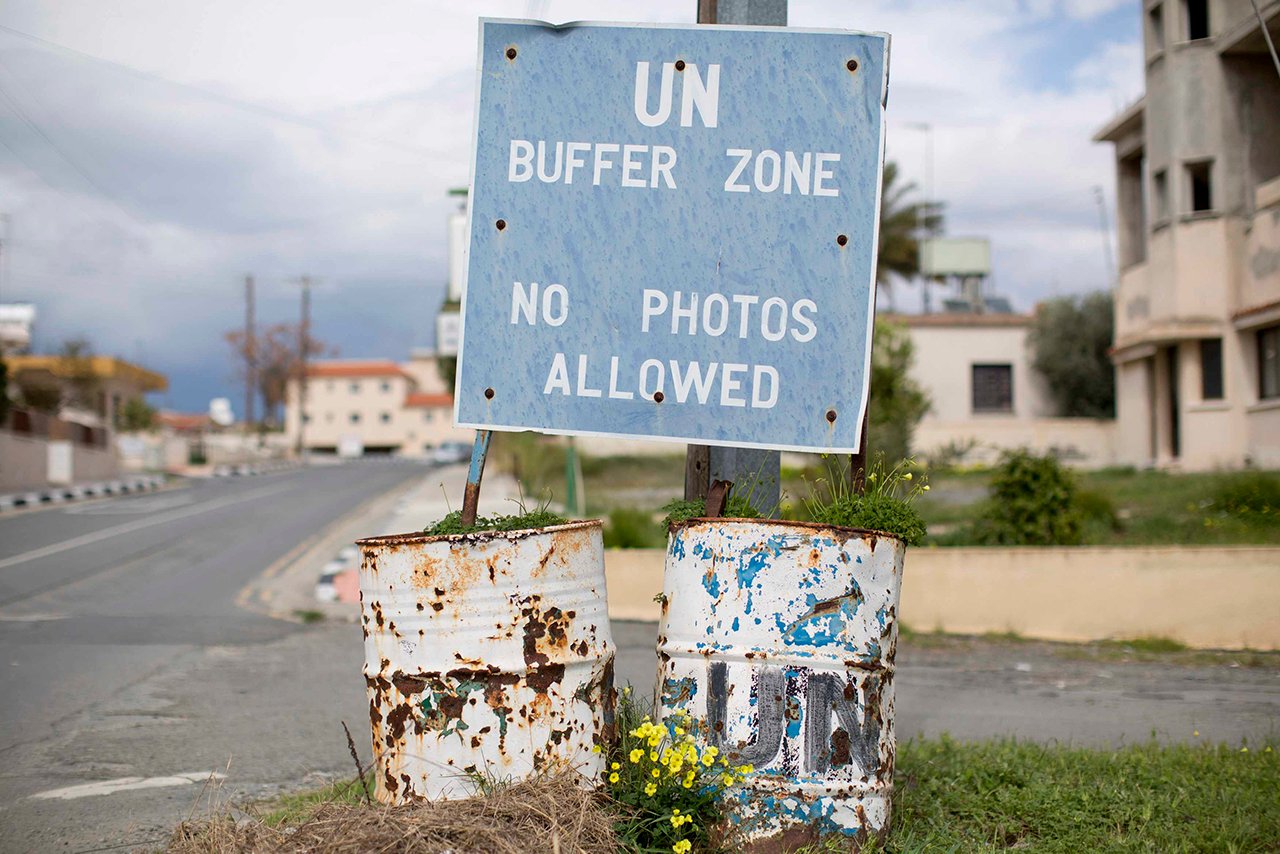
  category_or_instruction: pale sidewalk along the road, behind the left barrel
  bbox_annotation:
[237,463,520,622]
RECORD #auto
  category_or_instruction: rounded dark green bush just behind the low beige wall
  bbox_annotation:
[974,449,1085,545]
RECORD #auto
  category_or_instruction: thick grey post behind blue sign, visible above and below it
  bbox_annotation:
[685,0,787,515]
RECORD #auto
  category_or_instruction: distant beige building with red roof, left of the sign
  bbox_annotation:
[284,353,474,456]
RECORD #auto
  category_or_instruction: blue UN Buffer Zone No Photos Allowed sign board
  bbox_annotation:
[456,19,890,452]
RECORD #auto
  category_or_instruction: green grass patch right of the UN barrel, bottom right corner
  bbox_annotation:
[864,736,1280,854]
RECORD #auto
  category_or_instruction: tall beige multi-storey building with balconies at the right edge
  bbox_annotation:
[1094,0,1280,470]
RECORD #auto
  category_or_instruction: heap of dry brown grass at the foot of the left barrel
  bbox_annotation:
[168,776,618,854]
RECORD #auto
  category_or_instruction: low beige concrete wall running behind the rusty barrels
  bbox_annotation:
[604,547,1280,649]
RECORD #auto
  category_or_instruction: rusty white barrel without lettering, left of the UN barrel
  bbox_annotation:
[357,521,614,804]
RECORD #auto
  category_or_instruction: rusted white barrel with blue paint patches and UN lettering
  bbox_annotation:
[657,519,906,850]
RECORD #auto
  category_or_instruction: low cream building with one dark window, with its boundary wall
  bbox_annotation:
[883,312,1115,467]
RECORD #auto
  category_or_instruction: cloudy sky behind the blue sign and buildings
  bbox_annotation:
[0,0,1142,410]
